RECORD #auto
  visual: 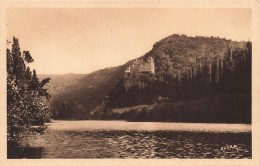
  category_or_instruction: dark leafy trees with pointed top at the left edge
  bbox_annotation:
[6,37,50,143]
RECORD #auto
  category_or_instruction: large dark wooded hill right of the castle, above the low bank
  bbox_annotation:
[108,35,252,108]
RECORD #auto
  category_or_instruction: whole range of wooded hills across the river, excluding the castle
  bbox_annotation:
[43,34,252,122]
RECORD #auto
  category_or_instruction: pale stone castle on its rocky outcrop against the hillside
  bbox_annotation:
[124,57,155,90]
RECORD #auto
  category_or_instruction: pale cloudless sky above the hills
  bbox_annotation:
[6,8,251,74]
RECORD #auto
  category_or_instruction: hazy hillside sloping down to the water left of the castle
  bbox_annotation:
[39,66,125,119]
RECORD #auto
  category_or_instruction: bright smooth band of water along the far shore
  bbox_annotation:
[46,120,252,133]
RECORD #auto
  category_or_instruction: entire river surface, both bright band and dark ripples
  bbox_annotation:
[17,121,252,158]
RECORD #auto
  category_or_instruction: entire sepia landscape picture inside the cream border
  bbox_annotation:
[1,0,254,165]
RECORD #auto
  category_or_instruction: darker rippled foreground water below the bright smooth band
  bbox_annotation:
[12,120,252,158]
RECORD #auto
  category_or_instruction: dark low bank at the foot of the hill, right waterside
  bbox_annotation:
[98,94,251,124]
